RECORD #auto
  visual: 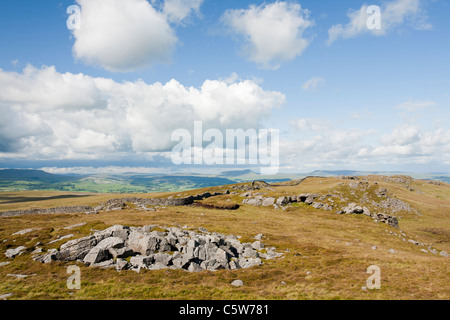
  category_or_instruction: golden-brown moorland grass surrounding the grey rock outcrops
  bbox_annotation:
[0,177,450,299]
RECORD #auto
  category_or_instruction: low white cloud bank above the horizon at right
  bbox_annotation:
[280,118,450,170]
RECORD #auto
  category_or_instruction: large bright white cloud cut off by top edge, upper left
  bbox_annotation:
[73,0,177,72]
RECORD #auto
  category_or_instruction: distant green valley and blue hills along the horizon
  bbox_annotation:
[0,169,450,193]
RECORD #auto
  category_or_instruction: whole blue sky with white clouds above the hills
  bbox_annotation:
[0,0,450,172]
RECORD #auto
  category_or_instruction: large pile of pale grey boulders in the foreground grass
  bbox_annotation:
[33,225,283,272]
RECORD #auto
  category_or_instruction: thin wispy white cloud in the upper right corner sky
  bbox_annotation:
[328,0,431,44]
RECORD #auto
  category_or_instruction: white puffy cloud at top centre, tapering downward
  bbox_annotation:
[223,2,313,69]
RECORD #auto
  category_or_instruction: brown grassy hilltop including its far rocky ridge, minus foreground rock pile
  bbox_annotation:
[0,175,450,299]
